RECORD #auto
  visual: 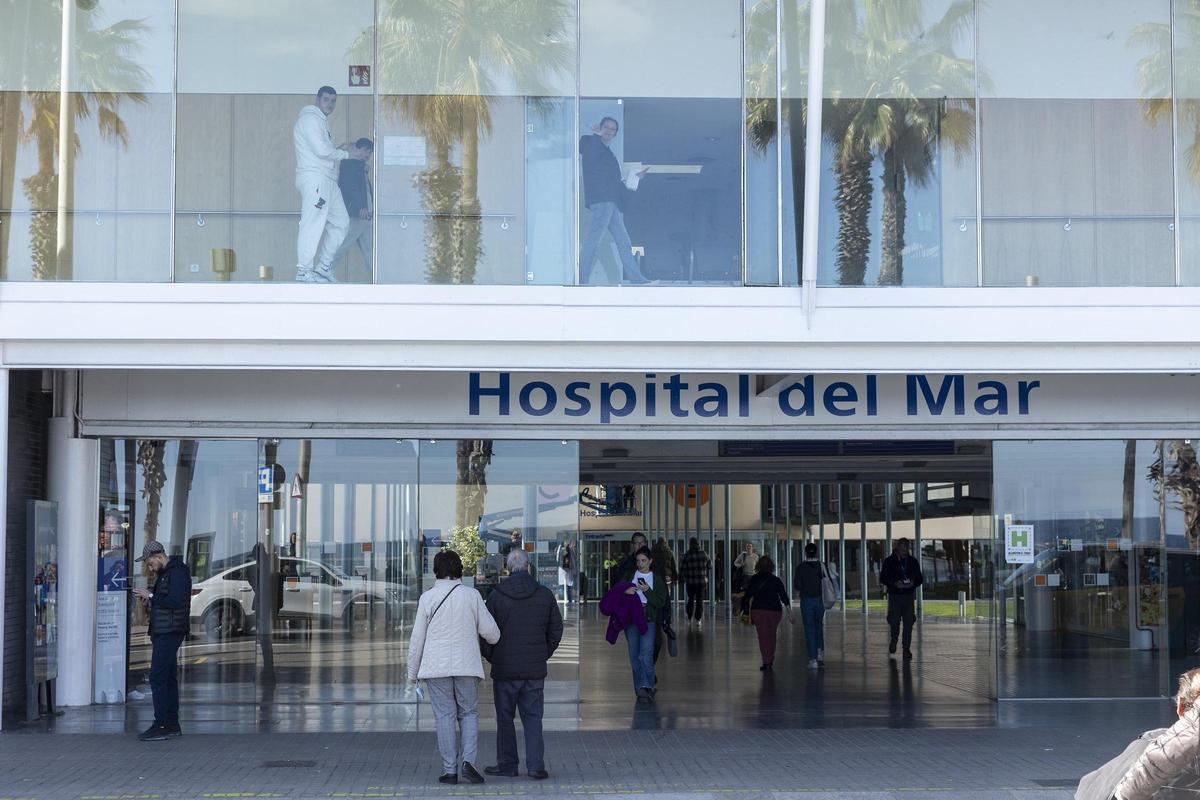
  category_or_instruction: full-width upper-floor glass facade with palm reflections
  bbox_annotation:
[7,0,1200,287]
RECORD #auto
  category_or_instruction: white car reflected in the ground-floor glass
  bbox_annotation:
[191,557,408,642]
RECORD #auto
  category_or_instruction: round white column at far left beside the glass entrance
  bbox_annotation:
[47,412,100,705]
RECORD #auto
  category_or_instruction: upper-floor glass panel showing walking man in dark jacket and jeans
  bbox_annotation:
[578,0,744,284]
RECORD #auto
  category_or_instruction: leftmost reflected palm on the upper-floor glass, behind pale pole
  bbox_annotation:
[0,0,149,279]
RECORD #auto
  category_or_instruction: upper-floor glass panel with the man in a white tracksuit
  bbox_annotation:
[175,0,374,282]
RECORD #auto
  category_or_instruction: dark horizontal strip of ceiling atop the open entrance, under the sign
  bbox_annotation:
[580,440,991,483]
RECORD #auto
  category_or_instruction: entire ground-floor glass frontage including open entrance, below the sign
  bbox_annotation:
[95,431,1200,705]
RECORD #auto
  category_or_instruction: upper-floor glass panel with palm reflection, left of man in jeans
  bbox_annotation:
[377,0,576,284]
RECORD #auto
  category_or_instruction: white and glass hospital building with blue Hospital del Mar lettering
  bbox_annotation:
[0,0,1200,712]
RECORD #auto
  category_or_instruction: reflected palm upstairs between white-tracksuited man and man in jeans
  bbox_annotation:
[354,0,575,283]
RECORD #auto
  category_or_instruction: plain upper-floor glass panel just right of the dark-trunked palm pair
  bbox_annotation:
[979,0,1175,285]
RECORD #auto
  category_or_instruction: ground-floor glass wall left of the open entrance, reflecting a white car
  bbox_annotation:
[96,439,578,714]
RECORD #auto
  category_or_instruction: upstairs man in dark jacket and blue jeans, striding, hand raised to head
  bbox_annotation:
[580,116,647,283]
